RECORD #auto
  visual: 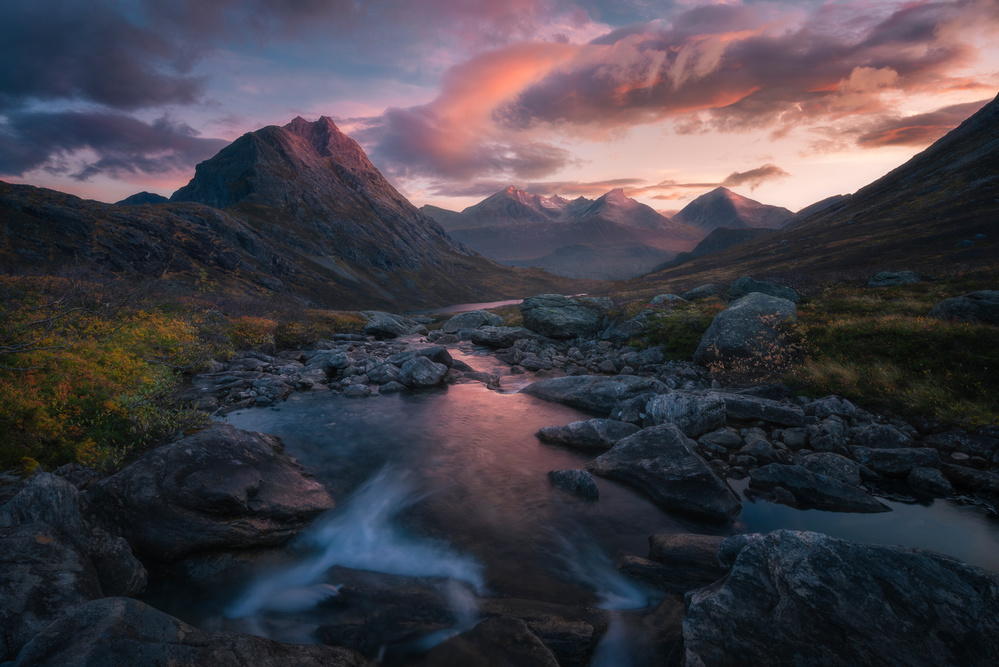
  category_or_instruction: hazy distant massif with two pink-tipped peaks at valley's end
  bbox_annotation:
[424,187,703,279]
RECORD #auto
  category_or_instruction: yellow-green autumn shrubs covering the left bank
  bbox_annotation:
[0,276,363,470]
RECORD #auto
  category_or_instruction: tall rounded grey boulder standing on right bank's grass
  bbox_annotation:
[694,292,798,365]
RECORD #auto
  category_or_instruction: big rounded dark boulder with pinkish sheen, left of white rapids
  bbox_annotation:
[87,424,333,561]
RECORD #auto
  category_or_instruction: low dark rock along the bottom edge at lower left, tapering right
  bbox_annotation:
[13,597,368,667]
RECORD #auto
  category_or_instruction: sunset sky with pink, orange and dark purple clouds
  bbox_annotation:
[0,0,999,211]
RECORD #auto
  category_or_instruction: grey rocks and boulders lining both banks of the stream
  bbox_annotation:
[0,285,999,666]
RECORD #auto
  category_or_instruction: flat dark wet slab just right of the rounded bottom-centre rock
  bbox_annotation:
[480,598,609,667]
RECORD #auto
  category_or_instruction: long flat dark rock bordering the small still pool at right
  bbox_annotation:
[749,463,891,513]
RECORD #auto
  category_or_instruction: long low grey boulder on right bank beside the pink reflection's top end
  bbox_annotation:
[521,375,669,416]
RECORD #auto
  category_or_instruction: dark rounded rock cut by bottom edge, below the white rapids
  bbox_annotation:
[413,616,559,667]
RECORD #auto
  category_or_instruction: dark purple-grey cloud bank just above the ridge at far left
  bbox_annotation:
[0,112,228,180]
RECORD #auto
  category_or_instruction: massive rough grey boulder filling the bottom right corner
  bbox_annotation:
[683,530,999,667]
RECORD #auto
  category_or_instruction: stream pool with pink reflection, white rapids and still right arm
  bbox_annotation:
[149,344,999,665]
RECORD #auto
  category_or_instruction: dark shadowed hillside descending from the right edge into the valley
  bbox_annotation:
[632,91,999,289]
